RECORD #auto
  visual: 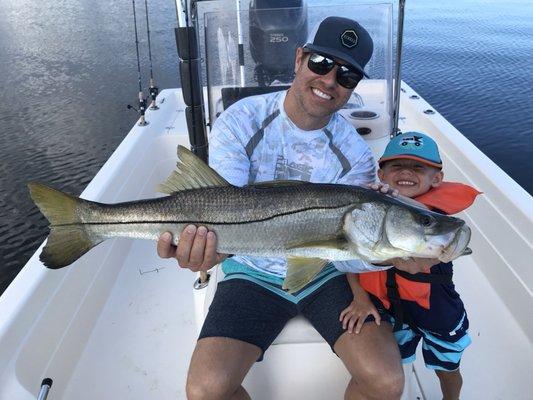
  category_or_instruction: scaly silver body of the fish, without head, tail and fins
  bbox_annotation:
[77,183,384,257]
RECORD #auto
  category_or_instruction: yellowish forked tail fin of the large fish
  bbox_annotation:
[28,182,103,269]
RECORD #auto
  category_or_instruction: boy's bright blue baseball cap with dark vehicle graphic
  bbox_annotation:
[378,132,442,168]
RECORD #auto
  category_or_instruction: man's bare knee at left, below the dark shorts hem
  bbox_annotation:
[187,337,262,400]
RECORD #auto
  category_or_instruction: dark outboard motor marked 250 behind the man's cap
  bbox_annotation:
[249,0,307,86]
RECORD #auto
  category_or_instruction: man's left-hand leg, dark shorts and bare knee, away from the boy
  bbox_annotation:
[187,279,298,400]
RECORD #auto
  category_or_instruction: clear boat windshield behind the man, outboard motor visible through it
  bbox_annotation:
[197,0,393,139]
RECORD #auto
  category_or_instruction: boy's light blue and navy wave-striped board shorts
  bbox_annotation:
[382,313,472,371]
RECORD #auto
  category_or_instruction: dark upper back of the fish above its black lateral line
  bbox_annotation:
[79,183,378,224]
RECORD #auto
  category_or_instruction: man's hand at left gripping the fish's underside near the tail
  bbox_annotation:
[157,225,228,272]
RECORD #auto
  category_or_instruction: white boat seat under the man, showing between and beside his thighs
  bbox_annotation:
[204,265,325,345]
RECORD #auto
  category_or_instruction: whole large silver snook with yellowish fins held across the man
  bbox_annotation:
[28,146,470,292]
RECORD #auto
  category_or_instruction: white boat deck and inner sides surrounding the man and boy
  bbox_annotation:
[0,88,533,400]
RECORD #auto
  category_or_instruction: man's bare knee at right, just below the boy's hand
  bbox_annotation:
[334,321,404,400]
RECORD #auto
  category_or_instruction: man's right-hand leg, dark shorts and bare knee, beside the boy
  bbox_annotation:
[301,275,404,400]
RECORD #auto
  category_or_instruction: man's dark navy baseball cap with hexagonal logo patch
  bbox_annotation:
[303,17,374,78]
